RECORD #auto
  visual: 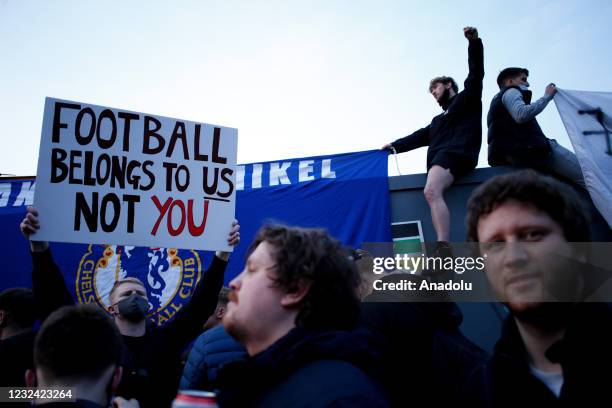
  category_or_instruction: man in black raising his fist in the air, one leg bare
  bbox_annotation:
[383,27,484,245]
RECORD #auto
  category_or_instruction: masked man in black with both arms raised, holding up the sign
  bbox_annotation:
[20,207,240,407]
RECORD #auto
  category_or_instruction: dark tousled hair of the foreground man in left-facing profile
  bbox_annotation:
[249,225,360,330]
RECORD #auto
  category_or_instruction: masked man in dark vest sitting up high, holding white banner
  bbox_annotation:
[487,67,586,188]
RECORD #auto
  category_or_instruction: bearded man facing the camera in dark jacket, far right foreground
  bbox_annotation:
[466,170,612,407]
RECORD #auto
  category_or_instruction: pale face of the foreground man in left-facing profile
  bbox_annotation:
[223,241,286,350]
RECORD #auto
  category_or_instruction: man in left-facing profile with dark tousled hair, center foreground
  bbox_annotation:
[218,226,387,407]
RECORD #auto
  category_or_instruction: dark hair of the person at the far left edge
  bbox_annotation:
[0,288,37,329]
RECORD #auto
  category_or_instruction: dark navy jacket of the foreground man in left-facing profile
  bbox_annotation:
[217,328,387,408]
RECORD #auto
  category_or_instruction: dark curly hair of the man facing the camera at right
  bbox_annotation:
[466,170,591,242]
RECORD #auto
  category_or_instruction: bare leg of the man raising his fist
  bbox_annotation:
[423,165,455,242]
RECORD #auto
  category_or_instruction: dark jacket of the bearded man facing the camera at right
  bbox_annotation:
[464,303,612,408]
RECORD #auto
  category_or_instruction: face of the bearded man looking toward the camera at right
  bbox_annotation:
[477,200,580,313]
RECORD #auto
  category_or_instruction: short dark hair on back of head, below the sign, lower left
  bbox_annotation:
[34,305,123,379]
